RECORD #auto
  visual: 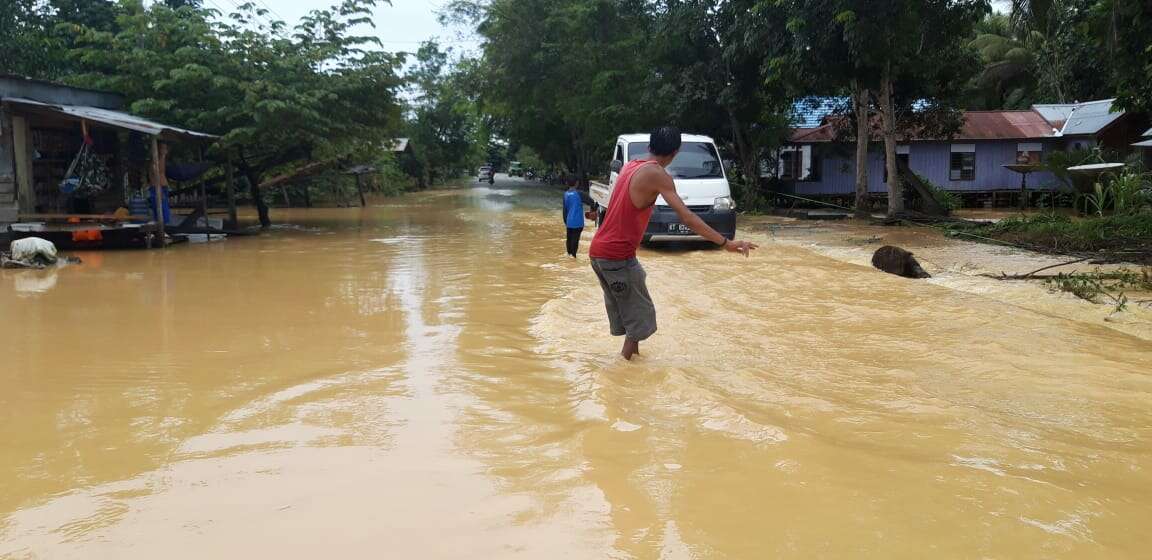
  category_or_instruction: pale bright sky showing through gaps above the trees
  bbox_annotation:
[204,0,479,52]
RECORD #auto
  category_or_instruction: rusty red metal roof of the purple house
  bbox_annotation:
[789,109,1053,143]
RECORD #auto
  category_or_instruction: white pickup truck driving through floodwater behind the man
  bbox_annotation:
[589,134,736,242]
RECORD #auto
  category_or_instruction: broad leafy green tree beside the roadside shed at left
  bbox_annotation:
[70,0,400,227]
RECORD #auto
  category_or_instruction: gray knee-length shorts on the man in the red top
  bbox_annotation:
[592,258,655,341]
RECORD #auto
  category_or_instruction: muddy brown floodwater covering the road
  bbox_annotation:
[0,188,1152,559]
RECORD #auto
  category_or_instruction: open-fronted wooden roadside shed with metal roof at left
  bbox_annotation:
[0,76,217,247]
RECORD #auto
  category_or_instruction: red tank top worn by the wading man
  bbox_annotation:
[588,159,654,260]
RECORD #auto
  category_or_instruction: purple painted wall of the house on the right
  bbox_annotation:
[791,141,1063,195]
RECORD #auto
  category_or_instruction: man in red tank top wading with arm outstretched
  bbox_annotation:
[589,127,756,360]
